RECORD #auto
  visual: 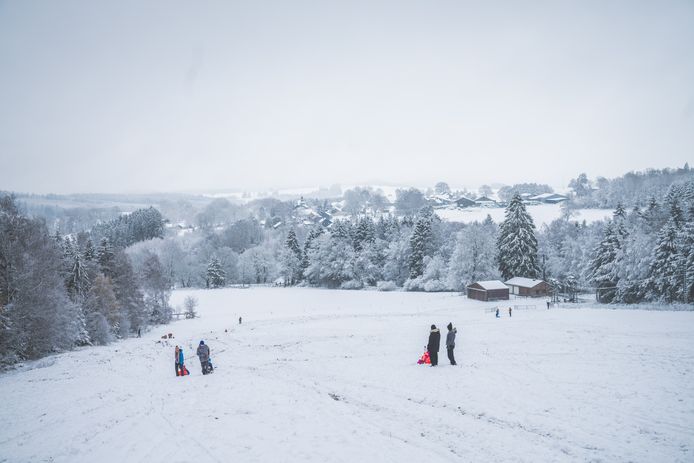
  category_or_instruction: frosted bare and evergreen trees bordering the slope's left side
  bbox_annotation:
[0,196,171,363]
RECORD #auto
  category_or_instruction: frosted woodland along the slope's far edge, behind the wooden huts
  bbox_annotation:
[119,181,694,303]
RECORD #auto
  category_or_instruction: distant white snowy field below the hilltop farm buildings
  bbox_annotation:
[436,204,613,227]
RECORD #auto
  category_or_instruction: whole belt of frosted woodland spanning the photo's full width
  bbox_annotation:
[0,169,694,363]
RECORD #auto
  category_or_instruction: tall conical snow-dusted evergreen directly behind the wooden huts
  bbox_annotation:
[497,194,540,279]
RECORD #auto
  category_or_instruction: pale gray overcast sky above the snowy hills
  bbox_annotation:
[0,0,694,193]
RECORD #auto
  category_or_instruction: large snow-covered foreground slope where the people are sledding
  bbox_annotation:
[0,288,694,463]
